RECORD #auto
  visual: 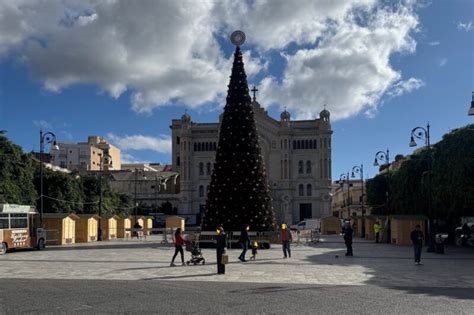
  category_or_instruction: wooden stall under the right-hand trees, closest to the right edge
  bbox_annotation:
[390,215,426,246]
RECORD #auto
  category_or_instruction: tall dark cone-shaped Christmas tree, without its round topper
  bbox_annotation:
[202,46,275,231]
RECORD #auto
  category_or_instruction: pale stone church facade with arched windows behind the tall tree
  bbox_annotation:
[170,97,332,224]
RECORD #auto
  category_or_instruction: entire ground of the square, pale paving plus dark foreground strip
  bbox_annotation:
[0,236,474,315]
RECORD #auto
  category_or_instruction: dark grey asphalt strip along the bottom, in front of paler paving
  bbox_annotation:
[0,279,474,314]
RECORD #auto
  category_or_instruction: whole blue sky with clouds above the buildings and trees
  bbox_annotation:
[0,0,474,180]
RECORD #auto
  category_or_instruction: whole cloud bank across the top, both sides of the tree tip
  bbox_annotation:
[0,0,418,119]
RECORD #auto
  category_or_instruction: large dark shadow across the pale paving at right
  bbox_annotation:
[306,237,474,299]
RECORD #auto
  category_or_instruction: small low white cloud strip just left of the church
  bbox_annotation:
[107,133,171,153]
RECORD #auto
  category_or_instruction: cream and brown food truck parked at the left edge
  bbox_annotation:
[0,204,46,255]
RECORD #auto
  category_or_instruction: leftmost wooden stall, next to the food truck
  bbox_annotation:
[43,213,79,245]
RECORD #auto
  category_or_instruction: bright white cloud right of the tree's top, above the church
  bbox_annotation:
[261,1,418,119]
